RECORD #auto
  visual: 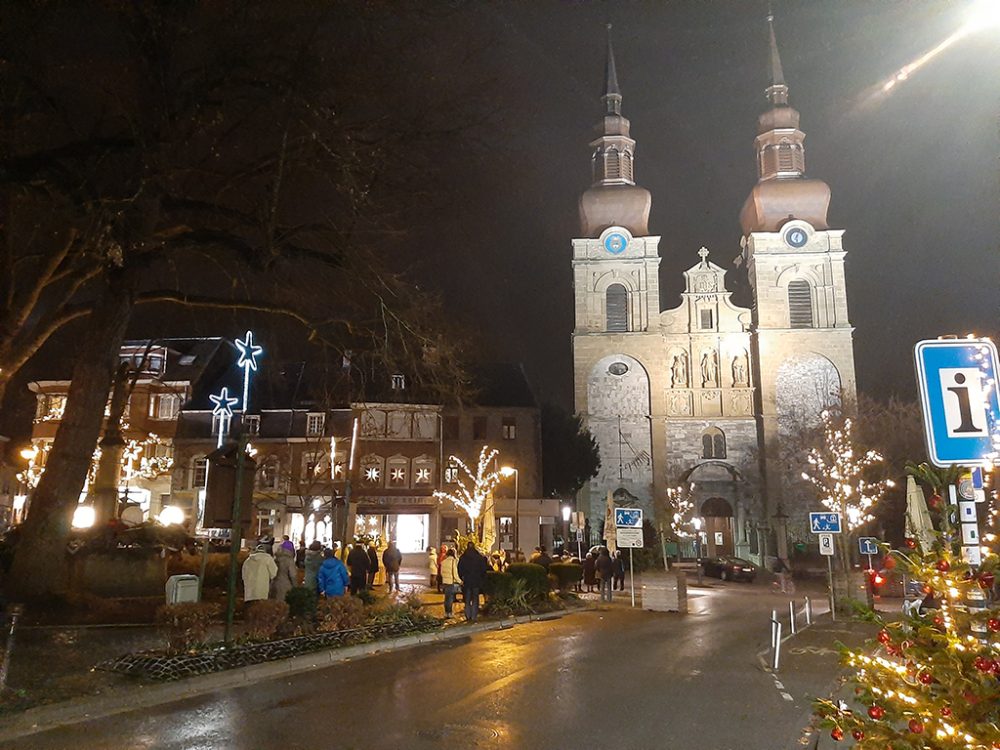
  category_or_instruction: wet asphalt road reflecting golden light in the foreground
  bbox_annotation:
[0,584,834,750]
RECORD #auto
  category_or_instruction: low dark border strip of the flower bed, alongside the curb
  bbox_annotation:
[97,618,441,682]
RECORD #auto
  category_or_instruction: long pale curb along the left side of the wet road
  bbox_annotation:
[0,607,589,742]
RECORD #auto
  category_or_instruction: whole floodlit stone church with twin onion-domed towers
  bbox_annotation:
[572,17,856,563]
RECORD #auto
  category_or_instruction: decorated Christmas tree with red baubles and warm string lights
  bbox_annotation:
[816,467,1000,750]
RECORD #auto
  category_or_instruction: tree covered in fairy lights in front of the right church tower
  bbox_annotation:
[802,411,893,572]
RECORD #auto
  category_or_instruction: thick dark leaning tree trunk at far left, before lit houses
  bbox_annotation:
[7,269,135,600]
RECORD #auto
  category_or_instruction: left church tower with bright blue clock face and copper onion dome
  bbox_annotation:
[573,26,667,530]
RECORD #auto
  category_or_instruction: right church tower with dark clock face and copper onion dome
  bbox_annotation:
[738,15,856,554]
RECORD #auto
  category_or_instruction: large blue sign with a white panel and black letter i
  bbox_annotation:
[913,339,1000,467]
